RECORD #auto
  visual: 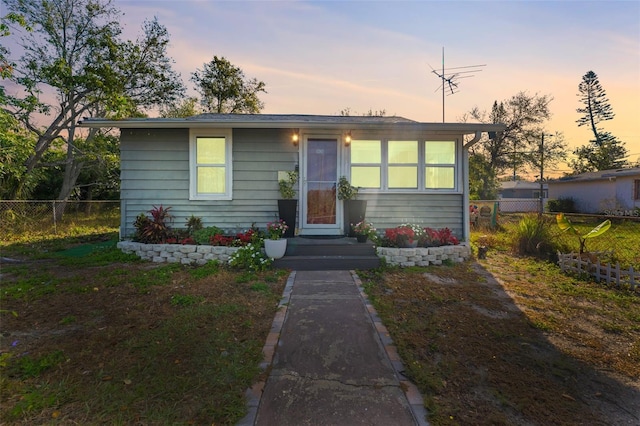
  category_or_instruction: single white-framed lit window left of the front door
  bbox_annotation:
[189,131,232,200]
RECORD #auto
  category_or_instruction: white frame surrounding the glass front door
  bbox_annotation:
[298,132,344,236]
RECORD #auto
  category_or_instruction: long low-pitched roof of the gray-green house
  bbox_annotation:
[78,114,505,134]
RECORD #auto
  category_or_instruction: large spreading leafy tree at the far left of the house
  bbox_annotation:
[5,0,184,215]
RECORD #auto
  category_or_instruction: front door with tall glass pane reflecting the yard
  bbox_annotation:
[301,137,341,235]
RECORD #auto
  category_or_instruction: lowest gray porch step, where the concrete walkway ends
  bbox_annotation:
[273,256,380,271]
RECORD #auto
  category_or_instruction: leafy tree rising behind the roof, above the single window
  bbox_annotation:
[191,56,267,114]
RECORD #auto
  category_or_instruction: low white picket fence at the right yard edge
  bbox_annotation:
[558,252,640,290]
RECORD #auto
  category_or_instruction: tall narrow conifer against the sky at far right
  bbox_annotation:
[569,71,627,173]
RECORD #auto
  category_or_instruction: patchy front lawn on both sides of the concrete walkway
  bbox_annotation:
[0,215,640,425]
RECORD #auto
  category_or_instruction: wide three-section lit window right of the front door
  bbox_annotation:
[351,139,457,191]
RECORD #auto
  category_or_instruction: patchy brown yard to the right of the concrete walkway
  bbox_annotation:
[363,256,640,425]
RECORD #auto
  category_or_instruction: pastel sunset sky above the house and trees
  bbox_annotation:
[5,0,640,175]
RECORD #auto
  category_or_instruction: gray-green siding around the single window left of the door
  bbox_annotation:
[120,129,298,236]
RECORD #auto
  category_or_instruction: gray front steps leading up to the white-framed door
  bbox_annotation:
[273,237,380,271]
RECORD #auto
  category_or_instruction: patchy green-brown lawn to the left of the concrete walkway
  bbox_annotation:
[0,225,286,425]
